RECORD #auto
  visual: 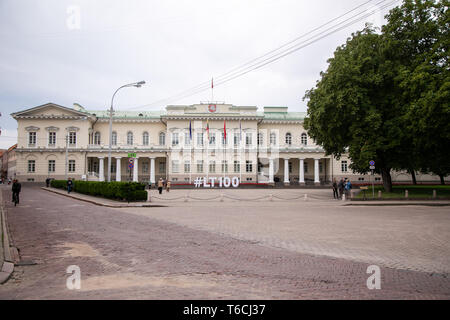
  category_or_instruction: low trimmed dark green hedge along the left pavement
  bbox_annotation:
[51,180,147,202]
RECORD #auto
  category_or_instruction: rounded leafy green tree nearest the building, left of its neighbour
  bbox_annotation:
[305,27,408,191]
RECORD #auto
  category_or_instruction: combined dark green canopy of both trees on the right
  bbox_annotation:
[305,0,450,191]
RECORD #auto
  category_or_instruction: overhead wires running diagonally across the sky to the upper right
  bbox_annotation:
[128,0,399,110]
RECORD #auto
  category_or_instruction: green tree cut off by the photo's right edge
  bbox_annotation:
[383,0,450,184]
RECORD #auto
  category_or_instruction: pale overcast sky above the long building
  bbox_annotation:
[0,0,399,148]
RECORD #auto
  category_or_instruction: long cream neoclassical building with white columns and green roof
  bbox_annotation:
[12,103,438,185]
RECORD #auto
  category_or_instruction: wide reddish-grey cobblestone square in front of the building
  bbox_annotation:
[0,186,450,299]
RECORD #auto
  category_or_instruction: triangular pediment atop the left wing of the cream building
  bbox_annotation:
[11,103,90,119]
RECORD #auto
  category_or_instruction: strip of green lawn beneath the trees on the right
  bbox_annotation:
[355,185,450,199]
